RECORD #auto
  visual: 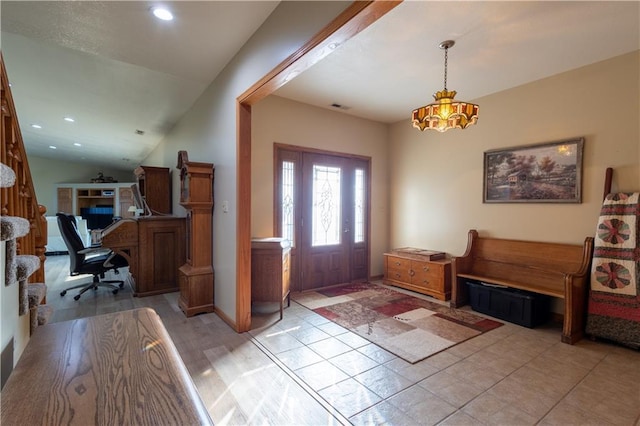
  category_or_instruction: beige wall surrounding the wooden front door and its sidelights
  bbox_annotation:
[251,96,389,275]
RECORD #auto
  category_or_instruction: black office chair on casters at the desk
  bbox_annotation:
[56,213,128,300]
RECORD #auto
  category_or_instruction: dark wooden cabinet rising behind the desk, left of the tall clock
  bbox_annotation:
[133,166,172,215]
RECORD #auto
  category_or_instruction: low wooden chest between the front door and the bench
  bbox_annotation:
[383,250,451,301]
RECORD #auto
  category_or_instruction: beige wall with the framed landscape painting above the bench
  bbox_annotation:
[389,51,640,255]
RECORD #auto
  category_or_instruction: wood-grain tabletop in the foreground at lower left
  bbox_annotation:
[1,308,213,425]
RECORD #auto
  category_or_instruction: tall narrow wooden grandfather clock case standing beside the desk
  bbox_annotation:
[177,151,214,317]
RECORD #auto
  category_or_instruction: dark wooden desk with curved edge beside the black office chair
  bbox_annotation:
[102,216,186,296]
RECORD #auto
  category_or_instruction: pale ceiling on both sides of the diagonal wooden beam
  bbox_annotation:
[0,1,640,170]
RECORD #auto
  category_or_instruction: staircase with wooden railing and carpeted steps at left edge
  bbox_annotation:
[0,53,53,383]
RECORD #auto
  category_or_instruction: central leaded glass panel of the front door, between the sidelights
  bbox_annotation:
[311,164,342,247]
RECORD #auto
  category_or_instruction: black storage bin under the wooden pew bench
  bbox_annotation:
[467,281,550,328]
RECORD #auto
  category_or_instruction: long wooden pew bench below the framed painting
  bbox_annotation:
[451,229,593,344]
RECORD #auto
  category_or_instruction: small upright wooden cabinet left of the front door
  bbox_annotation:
[251,238,291,319]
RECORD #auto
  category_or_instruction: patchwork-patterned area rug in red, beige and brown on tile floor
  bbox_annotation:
[292,283,502,363]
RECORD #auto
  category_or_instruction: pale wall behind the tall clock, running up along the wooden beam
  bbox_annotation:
[144,1,350,320]
